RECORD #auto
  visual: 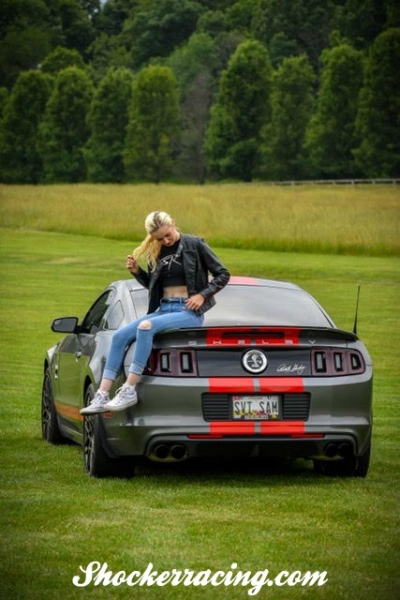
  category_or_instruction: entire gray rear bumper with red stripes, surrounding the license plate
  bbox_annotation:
[103,374,372,462]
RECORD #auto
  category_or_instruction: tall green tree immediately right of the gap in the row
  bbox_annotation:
[206,40,272,181]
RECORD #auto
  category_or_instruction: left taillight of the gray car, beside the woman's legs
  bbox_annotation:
[145,348,197,377]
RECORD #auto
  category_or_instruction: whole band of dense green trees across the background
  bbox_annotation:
[0,0,400,183]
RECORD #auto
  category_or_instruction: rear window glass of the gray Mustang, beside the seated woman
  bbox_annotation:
[204,285,334,327]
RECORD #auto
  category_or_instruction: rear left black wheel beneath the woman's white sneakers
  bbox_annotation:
[83,385,134,477]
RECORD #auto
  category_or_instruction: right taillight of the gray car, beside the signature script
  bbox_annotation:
[311,348,365,377]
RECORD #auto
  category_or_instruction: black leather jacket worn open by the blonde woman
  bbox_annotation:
[134,234,230,315]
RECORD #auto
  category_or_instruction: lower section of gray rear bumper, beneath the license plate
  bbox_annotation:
[105,418,372,462]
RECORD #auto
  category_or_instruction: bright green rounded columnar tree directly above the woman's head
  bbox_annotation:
[125,66,180,183]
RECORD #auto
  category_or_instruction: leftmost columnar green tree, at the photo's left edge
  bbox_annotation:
[0,71,53,183]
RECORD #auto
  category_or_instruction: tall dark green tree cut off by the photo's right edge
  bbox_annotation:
[354,28,400,177]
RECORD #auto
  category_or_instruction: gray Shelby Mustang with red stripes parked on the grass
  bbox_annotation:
[42,277,373,477]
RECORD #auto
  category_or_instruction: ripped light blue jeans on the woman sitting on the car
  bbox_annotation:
[103,298,204,381]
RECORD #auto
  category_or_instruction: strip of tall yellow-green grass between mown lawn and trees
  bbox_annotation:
[0,184,400,256]
